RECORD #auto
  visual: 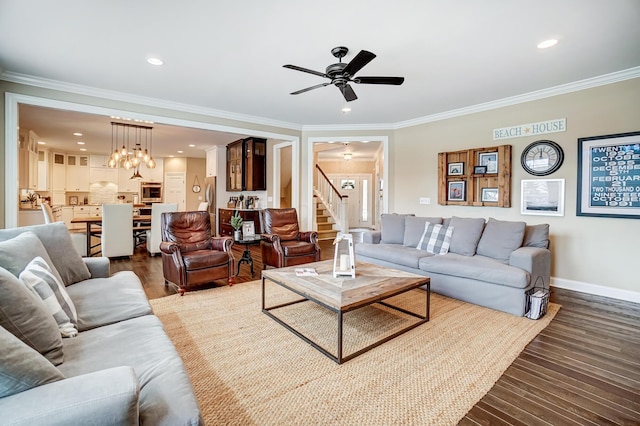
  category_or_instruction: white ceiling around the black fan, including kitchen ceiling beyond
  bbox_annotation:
[0,0,640,156]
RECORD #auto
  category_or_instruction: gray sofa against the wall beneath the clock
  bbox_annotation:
[355,214,551,316]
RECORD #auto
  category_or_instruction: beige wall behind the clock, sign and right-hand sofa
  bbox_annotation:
[391,79,640,301]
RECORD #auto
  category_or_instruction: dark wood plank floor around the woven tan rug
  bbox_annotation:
[111,241,640,425]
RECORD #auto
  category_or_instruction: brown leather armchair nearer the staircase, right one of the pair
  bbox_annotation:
[260,209,320,269]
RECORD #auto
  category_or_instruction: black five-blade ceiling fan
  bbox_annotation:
[283,46,404,102]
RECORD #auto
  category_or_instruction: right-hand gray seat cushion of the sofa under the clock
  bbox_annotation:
[419,255,530,289]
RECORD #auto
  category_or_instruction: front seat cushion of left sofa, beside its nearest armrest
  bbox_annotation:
[59,315,202,425]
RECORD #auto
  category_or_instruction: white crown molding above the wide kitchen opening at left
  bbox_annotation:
[0,71,302,131]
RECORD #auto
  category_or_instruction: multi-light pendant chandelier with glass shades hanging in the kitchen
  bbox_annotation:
[107,121,156,179]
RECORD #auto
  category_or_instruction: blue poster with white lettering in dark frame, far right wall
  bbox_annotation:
[576,132,640,219]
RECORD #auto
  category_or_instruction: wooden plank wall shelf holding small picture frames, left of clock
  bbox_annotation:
[438,145,511,207]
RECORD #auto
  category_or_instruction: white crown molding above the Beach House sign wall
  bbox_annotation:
[394,67,640,129]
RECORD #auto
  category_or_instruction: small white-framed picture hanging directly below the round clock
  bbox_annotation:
[520,179,564,216]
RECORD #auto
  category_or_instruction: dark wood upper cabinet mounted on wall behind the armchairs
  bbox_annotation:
[227,138,267,191]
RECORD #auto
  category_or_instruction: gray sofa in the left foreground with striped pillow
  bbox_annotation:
[0,222,203,425]
